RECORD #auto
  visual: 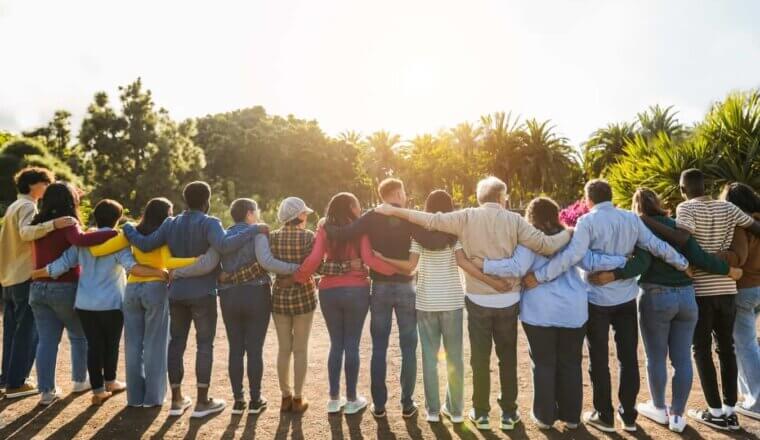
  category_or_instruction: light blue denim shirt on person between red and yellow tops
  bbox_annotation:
[47,228,137,311]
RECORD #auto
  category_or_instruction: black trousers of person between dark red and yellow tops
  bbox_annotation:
[77,309,124,392]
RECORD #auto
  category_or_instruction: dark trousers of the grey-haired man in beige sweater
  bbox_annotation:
[466,299,518,417]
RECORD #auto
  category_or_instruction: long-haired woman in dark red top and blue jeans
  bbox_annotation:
[29,182,116,406]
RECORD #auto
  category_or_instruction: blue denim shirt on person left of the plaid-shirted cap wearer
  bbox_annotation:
[220,223,299,289]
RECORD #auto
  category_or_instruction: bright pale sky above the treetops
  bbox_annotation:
[0,0,760,145]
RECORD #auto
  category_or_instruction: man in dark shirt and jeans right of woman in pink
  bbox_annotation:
[326,178,448,418]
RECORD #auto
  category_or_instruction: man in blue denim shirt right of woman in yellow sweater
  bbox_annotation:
[124,182,259,417]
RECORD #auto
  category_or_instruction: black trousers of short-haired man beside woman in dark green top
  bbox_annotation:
[586,300,640,423]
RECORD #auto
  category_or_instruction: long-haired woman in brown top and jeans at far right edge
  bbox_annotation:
[721,183,760,419]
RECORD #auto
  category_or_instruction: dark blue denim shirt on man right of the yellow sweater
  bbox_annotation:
[124,210,258,299]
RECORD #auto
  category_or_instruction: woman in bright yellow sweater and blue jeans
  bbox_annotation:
[90,197,202,408]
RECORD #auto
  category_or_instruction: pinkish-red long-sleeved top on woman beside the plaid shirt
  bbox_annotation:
[293,227,397,289]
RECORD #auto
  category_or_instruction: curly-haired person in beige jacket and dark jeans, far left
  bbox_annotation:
[0,168,77,398]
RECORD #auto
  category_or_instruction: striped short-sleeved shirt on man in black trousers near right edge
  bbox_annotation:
[676,196,753,296]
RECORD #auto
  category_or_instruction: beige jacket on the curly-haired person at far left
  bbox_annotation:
[0,194,55,287]
